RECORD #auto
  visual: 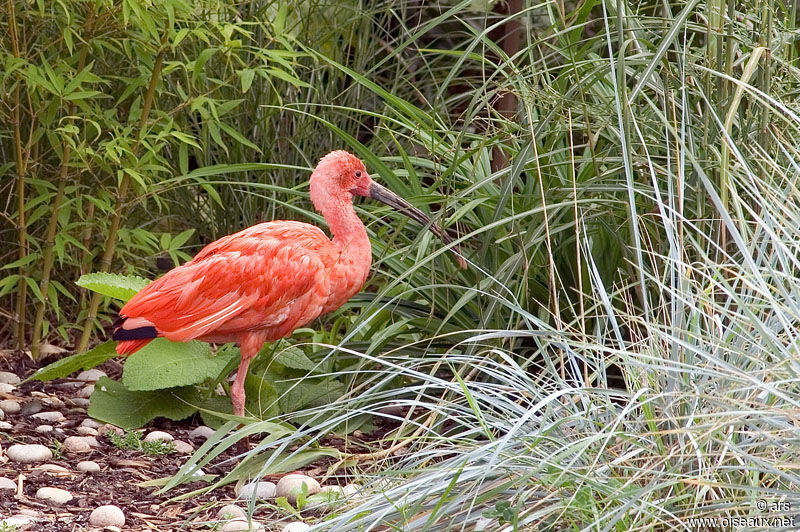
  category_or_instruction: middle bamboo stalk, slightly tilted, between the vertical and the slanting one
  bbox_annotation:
[31,6,94,360]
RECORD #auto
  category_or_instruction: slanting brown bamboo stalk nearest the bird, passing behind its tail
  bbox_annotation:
[78,32,169,352]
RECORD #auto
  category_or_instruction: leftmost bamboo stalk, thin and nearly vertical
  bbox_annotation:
[6,0,28,350]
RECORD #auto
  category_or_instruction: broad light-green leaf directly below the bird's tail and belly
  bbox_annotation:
[122,338,238,391]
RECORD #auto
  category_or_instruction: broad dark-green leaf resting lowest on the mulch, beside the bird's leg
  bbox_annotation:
[89,377,198,429]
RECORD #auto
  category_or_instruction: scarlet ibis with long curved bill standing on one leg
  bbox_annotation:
[112,151,466,416]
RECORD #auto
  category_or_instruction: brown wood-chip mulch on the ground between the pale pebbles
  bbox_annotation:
[0,356,396,532]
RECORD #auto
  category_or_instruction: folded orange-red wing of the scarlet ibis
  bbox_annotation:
[120,221,336,341]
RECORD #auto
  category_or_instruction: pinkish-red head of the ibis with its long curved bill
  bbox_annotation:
[309,150,467,268]
